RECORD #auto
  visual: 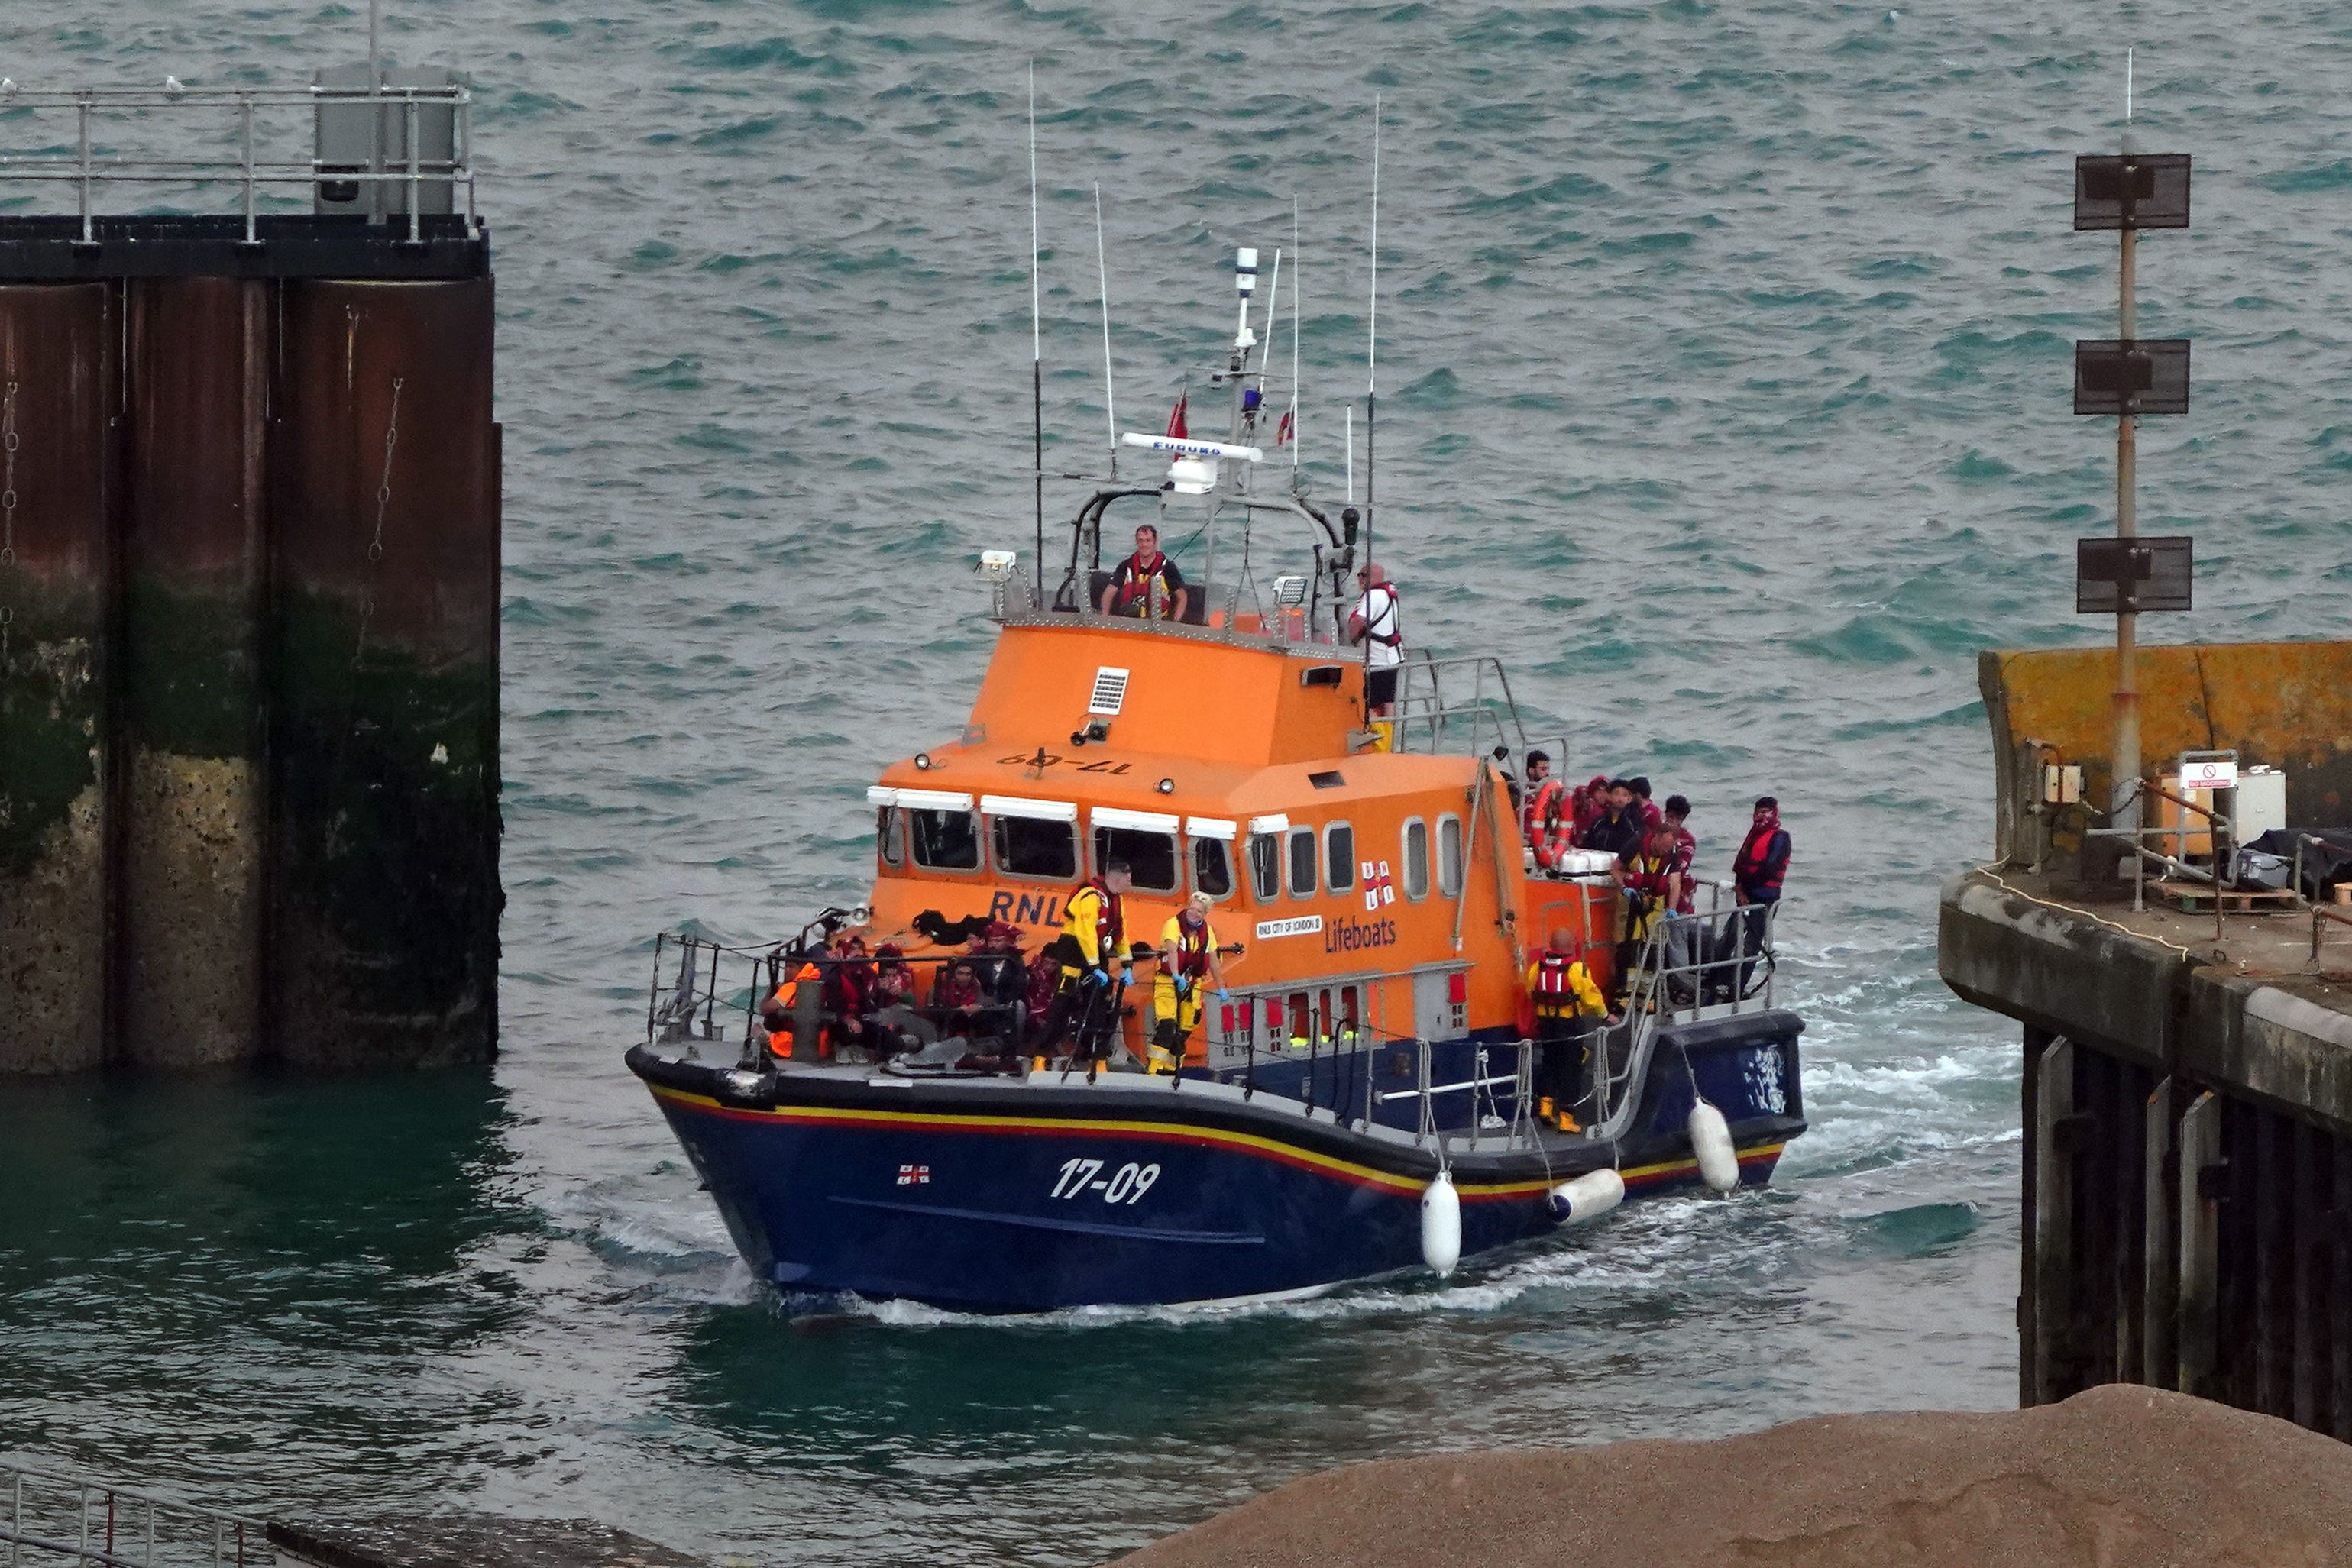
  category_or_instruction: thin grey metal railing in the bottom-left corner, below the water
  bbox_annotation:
[0,1457,277,1568]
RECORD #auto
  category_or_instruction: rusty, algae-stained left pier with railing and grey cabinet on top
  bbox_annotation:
[0,73,501,1072]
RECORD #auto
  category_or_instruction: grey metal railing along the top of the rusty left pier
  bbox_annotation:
[0,78,480,244]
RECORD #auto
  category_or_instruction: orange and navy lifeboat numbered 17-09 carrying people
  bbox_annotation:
[628,239,1804,1312]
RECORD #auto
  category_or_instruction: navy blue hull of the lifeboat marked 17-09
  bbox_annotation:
[630,1016,1804,1312]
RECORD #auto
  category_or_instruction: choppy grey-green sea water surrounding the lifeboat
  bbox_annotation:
[0,0,2352,1563]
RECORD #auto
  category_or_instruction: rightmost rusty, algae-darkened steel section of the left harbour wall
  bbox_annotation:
[270,277,499,1065]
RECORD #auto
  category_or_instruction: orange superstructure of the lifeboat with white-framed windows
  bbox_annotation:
[870,613,1613,1062]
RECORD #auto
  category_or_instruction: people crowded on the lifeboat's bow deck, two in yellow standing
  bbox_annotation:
[760,861,1225,1072]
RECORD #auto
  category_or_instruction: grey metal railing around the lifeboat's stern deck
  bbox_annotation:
[1590,902,1781,1138]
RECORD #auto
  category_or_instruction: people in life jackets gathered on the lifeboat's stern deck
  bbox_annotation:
[1517,750,1790,1130]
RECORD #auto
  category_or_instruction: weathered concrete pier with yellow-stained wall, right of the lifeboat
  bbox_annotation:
[1938,642,2352,1439]
